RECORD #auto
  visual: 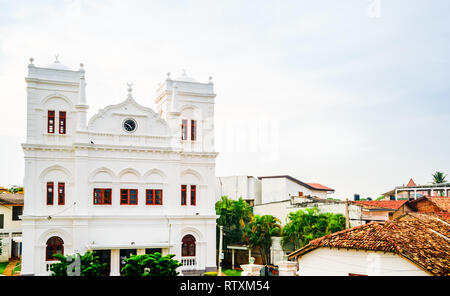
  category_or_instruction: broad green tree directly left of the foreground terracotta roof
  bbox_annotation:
[281,207,345,251]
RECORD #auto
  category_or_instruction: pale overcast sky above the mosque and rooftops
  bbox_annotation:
[0,0,450,198]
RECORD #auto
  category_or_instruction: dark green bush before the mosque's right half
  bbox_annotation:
[121,252,181,276]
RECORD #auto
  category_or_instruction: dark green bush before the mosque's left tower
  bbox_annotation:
[50,252,107,276]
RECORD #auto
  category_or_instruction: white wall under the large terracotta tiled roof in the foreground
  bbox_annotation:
[298,248,429,276]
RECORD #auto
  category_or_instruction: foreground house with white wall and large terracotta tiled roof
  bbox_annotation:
[288,213,450,276]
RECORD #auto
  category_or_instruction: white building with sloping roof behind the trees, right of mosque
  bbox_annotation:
[216,175,334,205]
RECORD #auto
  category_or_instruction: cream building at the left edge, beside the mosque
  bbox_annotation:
[0,193,24,262]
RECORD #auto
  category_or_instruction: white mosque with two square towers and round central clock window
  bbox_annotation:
[22,58,217,276]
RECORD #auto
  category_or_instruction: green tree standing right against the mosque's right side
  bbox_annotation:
[216,196,253,246]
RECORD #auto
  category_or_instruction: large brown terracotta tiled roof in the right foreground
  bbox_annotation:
[288,213,450,276]
